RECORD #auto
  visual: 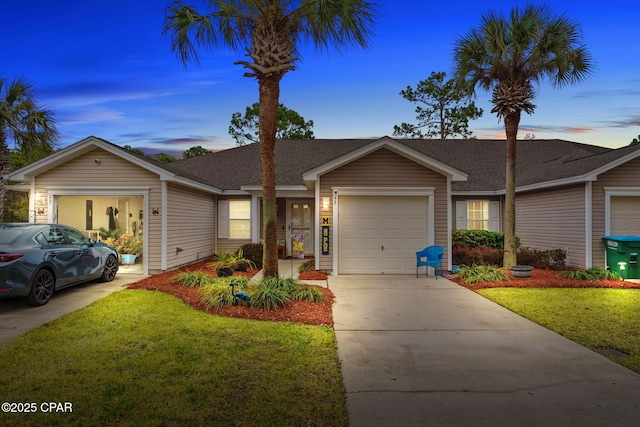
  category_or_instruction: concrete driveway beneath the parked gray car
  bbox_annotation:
[0,273,146,345]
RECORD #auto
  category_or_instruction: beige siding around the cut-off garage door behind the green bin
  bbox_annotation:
[592,159,640,267]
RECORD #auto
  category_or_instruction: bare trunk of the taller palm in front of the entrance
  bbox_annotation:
[258,75,281,277]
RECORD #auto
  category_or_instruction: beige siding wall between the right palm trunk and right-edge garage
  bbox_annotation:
[516,184,586,267]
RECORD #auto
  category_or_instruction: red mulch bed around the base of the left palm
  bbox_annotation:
[128,261,335,327]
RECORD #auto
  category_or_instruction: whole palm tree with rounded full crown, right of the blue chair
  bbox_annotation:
[454,5,593,267]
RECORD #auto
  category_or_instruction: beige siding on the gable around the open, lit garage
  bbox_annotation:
[36,148,162,270]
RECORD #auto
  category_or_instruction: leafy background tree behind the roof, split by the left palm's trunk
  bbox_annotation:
[229,102,314,145]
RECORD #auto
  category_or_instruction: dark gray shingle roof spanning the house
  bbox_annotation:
[154,139,640,192]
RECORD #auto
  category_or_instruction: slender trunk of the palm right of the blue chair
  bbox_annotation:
[503,111,520,268]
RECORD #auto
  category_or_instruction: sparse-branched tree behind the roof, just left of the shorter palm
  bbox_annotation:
[393,71,482,139]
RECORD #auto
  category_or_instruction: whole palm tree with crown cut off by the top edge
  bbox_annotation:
[163,0,375,277]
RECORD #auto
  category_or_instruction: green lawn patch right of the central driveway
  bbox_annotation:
[478,288,640,373]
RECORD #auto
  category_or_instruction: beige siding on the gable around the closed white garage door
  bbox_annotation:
[316,149,448,271]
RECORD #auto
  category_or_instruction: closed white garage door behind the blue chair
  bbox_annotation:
[338,196,427,274]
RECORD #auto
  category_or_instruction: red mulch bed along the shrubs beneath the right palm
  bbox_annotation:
[446,268,640,291]
